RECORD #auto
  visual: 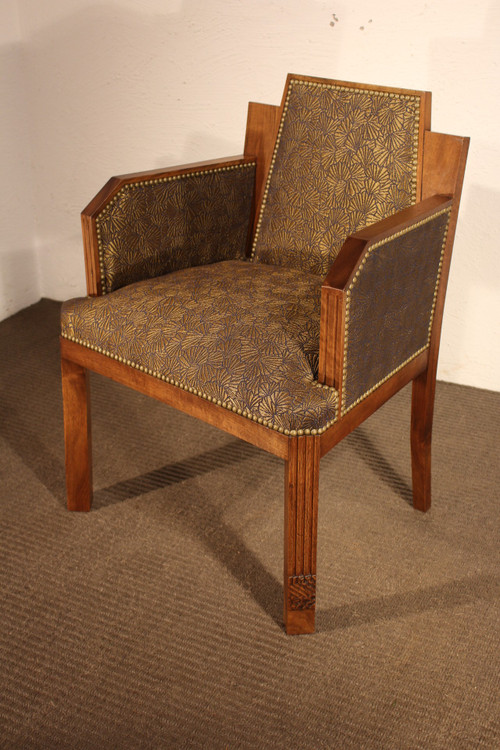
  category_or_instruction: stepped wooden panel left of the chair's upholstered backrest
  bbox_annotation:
[244,102,280,241]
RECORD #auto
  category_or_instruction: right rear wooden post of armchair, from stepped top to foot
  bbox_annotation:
[410,132,469,511]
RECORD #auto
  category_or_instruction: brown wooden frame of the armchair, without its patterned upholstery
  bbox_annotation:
[61,79,469,634]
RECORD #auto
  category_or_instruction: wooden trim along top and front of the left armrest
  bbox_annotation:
[82,156,255,296]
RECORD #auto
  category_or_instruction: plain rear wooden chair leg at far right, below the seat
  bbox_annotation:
[411,366,436,511]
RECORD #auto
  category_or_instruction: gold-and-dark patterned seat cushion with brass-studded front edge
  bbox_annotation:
[62,261,337,434]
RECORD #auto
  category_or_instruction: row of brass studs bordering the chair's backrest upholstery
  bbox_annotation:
[250,79,420,260]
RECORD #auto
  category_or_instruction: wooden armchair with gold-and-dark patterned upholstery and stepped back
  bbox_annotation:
[61,75,468,633]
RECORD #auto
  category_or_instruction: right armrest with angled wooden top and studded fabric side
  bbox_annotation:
[318,195,453,416]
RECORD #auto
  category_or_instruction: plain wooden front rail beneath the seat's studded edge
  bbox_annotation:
[61,338,288,458]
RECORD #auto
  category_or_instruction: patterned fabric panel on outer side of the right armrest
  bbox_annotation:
[342,208,450,414]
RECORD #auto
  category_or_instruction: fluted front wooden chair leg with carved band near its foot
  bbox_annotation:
[284,436,319,635]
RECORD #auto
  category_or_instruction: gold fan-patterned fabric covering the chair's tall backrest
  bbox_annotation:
[252,79,420,275]
